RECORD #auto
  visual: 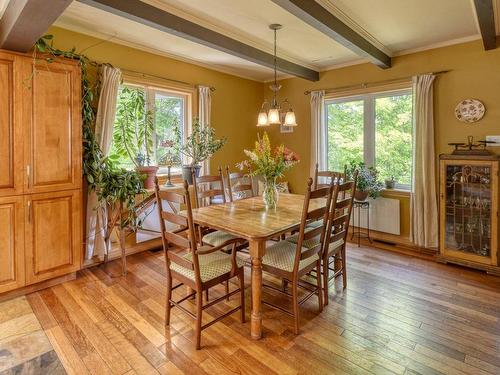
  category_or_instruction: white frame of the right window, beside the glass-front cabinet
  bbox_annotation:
[323,86,415,192]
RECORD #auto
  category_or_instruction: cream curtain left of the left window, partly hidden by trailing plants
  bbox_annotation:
[85,65,122,259]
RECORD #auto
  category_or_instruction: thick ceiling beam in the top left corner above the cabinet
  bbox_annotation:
[0,0,73,52]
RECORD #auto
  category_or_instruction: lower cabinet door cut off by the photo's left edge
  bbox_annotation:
[0,196,24,293]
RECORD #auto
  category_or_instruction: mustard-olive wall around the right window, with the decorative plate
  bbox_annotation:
[264,41,500,237]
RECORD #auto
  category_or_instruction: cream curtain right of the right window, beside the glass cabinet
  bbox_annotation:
[411,74,438,248]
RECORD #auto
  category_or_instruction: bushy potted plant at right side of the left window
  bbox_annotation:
[175,118,226,184]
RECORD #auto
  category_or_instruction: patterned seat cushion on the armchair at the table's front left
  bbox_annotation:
[170,251,245,282]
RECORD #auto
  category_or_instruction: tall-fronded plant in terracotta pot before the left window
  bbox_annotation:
[110,86,158,189]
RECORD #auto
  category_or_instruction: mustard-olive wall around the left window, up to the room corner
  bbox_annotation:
[48,27,263,170]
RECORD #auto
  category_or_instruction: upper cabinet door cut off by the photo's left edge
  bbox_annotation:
[0,52,24,197]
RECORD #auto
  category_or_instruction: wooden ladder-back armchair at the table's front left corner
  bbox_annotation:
[155,179,245,349]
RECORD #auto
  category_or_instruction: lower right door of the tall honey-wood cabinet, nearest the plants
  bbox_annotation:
[25,191,82,284]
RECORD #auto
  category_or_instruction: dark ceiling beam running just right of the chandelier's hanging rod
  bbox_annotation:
[272,0,391,69]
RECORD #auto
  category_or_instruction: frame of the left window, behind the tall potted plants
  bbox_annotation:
[120,76,196,176]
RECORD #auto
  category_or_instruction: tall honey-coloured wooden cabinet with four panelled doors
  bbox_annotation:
[0,50,83,294]
